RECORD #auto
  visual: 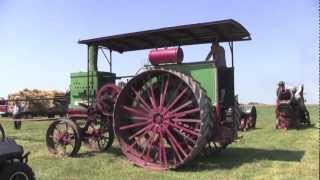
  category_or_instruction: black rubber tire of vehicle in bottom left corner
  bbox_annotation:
[0,162,35,180]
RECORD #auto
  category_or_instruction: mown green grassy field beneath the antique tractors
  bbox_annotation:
[0,106,319,180]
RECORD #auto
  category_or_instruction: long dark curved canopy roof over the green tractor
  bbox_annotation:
[79,19,251,53]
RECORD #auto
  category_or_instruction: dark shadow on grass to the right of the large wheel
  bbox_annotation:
[177,148,305,171]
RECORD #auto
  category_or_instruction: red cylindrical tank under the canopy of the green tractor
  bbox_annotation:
[149,47,183,65]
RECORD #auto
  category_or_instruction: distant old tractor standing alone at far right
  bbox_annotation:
[275,81,310,129]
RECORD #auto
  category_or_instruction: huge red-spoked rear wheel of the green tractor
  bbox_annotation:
[114,69,212,170]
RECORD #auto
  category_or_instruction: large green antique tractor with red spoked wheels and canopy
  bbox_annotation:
[47,20,251,170]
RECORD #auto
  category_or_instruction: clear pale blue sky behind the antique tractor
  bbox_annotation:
[0,0,319,103]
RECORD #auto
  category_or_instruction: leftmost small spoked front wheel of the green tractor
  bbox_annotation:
[46,119,81,156]
